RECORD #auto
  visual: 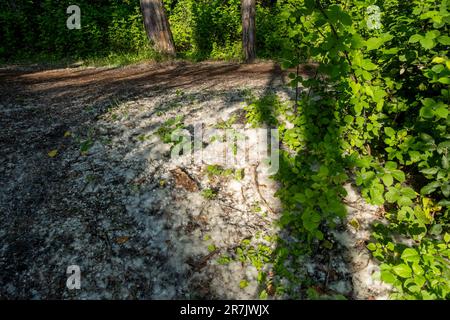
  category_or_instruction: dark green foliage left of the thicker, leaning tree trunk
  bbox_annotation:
[0,0,152,60]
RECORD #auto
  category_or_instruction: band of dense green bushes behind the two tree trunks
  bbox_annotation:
[0,0,289,60]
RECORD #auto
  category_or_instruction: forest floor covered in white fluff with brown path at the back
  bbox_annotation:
[0,62,389,299]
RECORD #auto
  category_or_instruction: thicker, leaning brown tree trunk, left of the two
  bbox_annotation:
[140,0,175,56]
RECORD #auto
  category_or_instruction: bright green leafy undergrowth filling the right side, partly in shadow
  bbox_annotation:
[251,0,450,299]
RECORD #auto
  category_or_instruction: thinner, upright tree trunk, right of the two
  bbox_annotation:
[241,0,256,62]
